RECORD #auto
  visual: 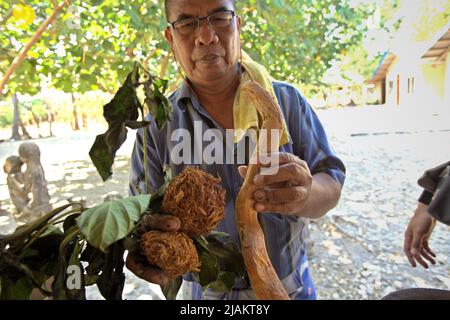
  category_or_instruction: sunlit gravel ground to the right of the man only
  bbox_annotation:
[310,132,450,299]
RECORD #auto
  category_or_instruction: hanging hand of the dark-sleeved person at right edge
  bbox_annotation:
[403,202,436,269]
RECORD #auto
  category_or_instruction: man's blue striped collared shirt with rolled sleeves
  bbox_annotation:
[130,82,345,299]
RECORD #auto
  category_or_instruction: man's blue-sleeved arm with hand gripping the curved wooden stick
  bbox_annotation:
[240,85,345,218]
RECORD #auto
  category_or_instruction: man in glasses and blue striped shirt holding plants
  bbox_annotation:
[127,0,345,299]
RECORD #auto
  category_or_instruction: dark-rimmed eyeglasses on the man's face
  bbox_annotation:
[169,10,235,35]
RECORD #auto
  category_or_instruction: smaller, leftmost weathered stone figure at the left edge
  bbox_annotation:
[3,156,30,216]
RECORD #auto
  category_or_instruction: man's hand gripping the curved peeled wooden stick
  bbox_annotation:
[239,152,312,215]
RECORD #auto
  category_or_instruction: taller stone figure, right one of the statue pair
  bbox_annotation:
[19,142,52,220]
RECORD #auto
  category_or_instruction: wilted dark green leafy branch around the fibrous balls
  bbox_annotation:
[0,63,244,300]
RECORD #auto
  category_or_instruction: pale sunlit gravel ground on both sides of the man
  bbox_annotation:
[0,107,450,299]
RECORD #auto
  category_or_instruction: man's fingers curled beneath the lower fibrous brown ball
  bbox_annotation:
[126,252,169,286]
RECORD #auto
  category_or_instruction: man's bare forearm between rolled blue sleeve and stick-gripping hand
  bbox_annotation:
[298,173,342,219]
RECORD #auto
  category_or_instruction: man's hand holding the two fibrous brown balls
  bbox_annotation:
[126,214,181,286]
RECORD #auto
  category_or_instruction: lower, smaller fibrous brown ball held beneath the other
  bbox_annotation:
[140,230,200,278]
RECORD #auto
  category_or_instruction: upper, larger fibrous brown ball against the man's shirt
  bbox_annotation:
[162,167,225,237]
